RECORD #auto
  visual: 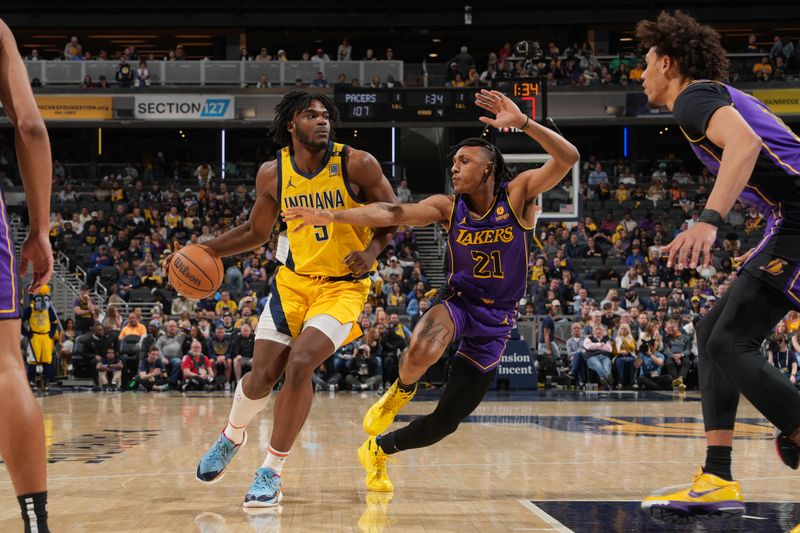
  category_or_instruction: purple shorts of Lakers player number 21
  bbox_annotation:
[442,294,516,373]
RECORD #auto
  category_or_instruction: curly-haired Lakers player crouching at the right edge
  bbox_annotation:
[637,12,800,521]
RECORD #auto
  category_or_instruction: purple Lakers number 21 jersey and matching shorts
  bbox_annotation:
[443,182,533,373]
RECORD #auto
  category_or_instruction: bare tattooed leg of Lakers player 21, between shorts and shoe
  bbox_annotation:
[400,304,455,385]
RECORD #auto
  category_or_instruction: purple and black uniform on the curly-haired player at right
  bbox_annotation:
[673,80,800,308]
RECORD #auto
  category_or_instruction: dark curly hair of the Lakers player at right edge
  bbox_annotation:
[636,11,728,80]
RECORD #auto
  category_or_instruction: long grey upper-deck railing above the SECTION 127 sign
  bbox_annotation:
[25,60,404,87]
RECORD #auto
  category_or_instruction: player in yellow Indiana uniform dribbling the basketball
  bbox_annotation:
[180,92,396,507]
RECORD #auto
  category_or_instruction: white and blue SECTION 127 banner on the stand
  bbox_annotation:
[133,94,234,120]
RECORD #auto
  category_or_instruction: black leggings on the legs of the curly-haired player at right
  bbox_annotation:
[697,272,800,479]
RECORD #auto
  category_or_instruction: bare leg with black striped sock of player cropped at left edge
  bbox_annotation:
[0,319,48,532]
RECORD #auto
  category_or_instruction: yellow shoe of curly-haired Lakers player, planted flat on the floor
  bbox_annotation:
[642,469,744,524]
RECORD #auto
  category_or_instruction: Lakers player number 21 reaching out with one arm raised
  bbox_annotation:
[284,90,579,492]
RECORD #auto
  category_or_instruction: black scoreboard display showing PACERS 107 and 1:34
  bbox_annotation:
[334,79,546,123]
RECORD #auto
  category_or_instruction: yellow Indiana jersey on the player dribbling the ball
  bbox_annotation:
[277,143,372,277]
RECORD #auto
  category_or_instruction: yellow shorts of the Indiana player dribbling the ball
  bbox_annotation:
[256,266,372,348]
